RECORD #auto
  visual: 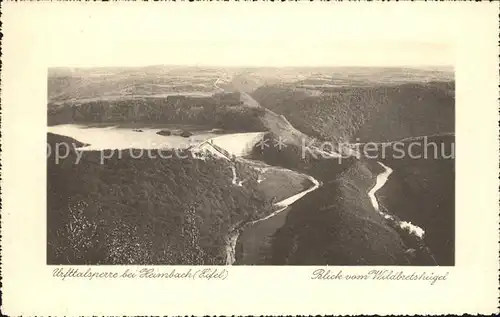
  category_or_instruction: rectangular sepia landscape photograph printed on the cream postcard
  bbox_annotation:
[47,61,455,266]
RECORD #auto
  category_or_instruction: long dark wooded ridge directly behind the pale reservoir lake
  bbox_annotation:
[48,94,265,131]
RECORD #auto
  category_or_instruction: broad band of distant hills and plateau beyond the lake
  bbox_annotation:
[48,66,455,146]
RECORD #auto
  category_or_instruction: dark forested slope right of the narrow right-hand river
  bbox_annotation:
[380,135,455,265]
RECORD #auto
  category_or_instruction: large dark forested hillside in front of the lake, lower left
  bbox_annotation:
[47,134,272,264]
